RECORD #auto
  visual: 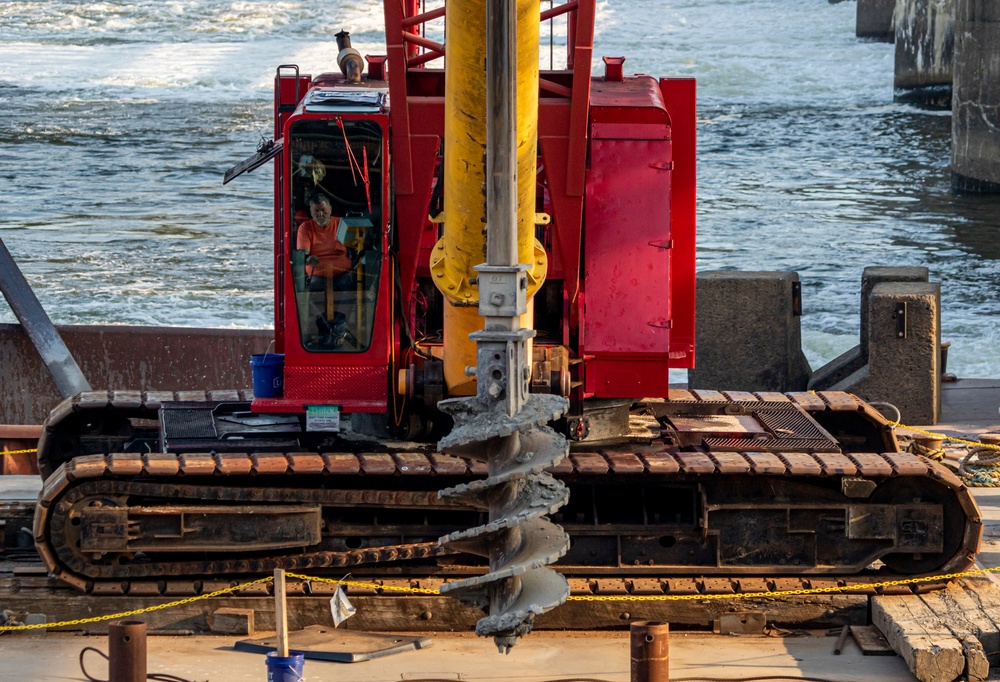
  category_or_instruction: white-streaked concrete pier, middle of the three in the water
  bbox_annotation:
[893,0,955,109]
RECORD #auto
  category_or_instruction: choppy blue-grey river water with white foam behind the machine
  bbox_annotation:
[0,0,1000,377]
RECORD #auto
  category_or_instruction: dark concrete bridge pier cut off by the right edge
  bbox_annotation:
[951,0,1000,193]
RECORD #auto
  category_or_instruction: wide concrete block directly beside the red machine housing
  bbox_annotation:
[688,270,810,391]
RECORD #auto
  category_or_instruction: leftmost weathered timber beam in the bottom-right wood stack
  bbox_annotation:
[871,596,965,682]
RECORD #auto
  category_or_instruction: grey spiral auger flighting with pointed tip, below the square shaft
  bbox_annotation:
[438,388,569,652]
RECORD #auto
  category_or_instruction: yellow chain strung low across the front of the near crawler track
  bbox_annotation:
[0,566,1000,632]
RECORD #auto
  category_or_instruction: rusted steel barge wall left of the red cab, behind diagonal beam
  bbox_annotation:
[0,324,274,424]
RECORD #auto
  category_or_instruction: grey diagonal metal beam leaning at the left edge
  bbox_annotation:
[0,239,91,398]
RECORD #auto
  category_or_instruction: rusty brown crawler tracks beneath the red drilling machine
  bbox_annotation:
[34,392,982,595]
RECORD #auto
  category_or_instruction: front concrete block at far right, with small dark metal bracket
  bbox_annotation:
[836,282,941,425]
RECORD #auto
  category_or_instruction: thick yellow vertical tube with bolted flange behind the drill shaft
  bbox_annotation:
[430,0,547,395]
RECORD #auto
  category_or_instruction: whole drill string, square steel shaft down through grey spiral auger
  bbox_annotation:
[438,0,569,653]
